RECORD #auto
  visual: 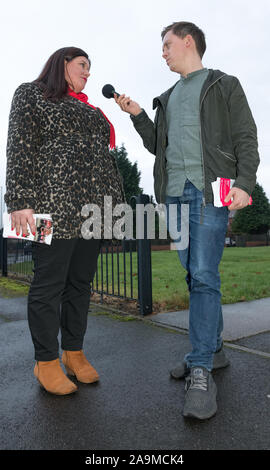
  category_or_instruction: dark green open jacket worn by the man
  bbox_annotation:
[131,69,260,205]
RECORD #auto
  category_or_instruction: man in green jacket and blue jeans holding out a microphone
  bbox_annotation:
[115,22,259,419]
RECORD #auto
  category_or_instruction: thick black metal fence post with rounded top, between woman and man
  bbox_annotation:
[134,194,152,315]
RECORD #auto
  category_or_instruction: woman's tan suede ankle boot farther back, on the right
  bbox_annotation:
[62,350,99,384]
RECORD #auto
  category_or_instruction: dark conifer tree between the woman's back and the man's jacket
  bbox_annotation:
[110,144,143,204]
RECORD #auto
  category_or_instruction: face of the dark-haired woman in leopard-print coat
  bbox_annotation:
[65,56,90,93]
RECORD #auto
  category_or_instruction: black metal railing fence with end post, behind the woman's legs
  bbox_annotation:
[0,195,152,315]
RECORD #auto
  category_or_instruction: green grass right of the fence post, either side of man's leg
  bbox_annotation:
[152,246,270,310]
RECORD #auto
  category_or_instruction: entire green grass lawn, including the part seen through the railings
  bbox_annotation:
[3,246,270,311]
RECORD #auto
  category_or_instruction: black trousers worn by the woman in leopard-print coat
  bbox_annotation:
[28,239,100,361]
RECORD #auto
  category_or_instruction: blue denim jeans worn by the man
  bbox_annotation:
[166,180,229,371]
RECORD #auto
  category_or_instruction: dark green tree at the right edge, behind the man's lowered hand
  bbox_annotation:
[231,183,270,234]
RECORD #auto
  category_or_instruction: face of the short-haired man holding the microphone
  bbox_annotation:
[162,31,187,73]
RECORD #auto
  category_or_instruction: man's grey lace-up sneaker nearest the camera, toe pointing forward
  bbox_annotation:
[183,366,217,419]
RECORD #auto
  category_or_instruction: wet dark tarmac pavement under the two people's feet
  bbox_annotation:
[0,297,270,450]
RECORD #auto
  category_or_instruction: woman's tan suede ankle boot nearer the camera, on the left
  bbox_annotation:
[34,358,78,395]
